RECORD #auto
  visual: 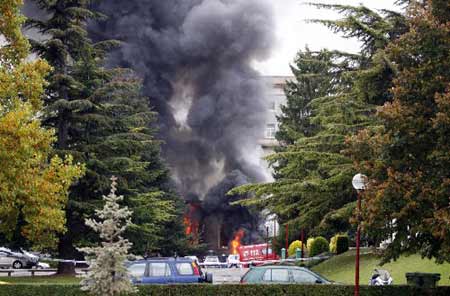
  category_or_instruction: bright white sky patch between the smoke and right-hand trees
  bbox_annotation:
[255,0,399,75]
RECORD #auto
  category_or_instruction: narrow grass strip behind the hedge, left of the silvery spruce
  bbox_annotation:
[0,275,81,285]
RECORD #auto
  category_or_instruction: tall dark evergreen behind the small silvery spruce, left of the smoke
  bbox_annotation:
[29,0,186,264]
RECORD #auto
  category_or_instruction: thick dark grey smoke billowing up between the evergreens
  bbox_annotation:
[91,0,274,199]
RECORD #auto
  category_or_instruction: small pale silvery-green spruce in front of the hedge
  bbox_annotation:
[80,177,136,296]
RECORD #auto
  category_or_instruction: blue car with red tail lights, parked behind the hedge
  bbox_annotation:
[127,258,212,284]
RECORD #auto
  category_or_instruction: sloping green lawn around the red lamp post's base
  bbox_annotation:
[312,250,450,285]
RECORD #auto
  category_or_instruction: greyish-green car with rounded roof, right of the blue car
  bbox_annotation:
[241,264,332,285]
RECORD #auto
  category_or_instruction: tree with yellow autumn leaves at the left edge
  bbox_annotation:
[0,1,82,249]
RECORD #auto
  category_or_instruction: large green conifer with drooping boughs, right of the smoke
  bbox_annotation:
[234,4,405,235]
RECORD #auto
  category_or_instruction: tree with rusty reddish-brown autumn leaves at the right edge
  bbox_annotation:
[349,0,450,262]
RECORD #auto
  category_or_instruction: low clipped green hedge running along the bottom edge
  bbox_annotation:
[0,285,450,296]
